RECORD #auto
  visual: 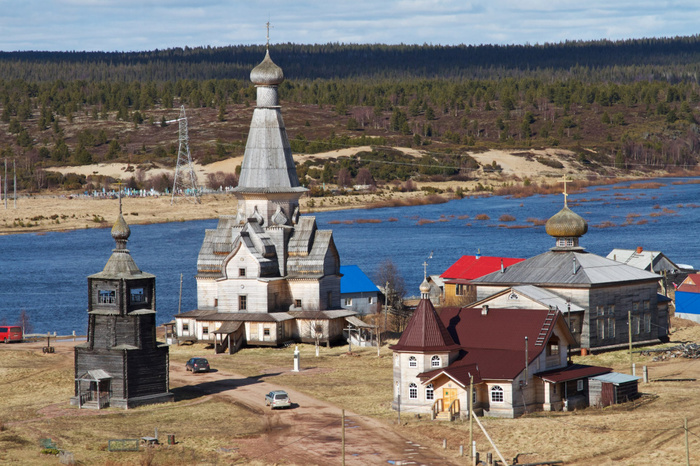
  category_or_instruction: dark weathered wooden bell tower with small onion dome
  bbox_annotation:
[71,208,174,409]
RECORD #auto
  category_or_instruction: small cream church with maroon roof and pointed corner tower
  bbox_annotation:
[391,281,611,420]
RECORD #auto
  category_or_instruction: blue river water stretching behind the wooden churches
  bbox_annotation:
[0,178,700,334]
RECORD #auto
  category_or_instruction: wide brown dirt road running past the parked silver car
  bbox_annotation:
[170,366,458,465]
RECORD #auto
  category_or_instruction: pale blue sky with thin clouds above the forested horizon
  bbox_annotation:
[0,0,700,51]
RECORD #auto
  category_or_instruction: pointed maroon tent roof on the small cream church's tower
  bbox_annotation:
[390,299,459,351]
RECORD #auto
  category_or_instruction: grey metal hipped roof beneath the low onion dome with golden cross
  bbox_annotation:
[473,251,659,286]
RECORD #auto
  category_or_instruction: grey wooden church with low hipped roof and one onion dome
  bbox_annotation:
[473,198,669,348]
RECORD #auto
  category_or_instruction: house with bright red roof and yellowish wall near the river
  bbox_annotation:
[440,254,525,306]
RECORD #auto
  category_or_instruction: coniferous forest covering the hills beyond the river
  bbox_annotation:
[0,36,700,191]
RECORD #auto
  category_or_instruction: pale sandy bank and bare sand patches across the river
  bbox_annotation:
[0,147,644,234]
